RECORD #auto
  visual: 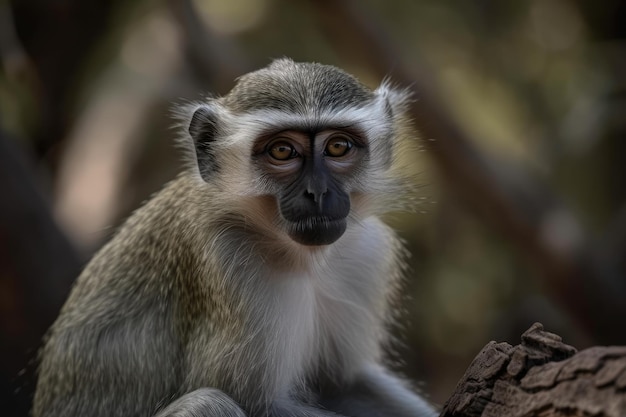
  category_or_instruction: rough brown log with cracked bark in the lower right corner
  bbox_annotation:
[441,323,626,417]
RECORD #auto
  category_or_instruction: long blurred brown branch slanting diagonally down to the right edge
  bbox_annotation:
[310,0,626,344]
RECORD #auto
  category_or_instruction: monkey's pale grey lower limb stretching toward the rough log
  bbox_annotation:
[322,365,439,417]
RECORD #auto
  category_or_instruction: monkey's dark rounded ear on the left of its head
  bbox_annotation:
[189,105,219,182]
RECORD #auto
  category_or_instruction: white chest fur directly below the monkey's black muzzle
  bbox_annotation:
[264,220,395,393]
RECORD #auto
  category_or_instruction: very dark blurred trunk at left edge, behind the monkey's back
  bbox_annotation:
[0,131,81,417]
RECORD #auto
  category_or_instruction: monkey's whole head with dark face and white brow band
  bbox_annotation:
[186,59,409,246]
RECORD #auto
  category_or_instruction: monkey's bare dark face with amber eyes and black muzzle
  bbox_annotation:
[253,129,368,245]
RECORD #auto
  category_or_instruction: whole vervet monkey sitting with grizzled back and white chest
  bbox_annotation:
[33,59,435,417]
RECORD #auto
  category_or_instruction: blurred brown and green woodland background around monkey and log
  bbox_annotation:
[0,0,626,416]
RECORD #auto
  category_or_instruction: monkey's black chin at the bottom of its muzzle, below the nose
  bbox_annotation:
[287,217,347,246]
